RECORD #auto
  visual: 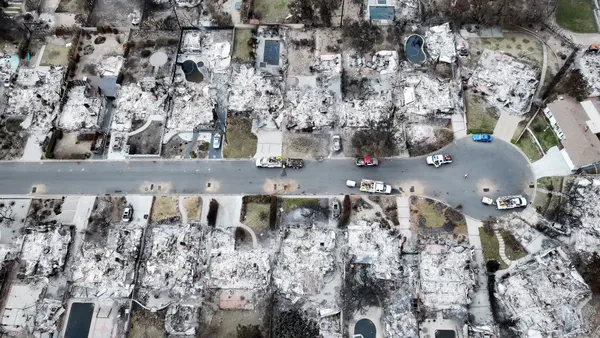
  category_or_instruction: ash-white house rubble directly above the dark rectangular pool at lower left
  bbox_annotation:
[70,226,143,298]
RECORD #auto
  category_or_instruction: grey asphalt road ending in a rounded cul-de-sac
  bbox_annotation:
[0,138,534,218]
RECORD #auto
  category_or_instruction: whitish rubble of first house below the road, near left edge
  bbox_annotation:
[21,225,71,277]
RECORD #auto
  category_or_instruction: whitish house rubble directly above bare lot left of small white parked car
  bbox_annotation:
[286,88,339,129]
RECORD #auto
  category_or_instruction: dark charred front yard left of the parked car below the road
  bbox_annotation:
[84,196,127,242]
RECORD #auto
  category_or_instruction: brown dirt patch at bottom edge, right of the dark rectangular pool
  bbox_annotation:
[127,303,167,338]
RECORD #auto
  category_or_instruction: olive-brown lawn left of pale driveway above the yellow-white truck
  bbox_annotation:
[223,116,258,158]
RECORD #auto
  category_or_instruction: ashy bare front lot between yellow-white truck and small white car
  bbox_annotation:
[283,133,331,159]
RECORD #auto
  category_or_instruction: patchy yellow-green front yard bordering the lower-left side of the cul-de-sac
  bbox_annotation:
[410,196,467,234]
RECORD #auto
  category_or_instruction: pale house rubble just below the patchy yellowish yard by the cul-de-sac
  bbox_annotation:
[419,244,475,311]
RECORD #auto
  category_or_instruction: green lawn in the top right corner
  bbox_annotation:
[556,0,598,33]
